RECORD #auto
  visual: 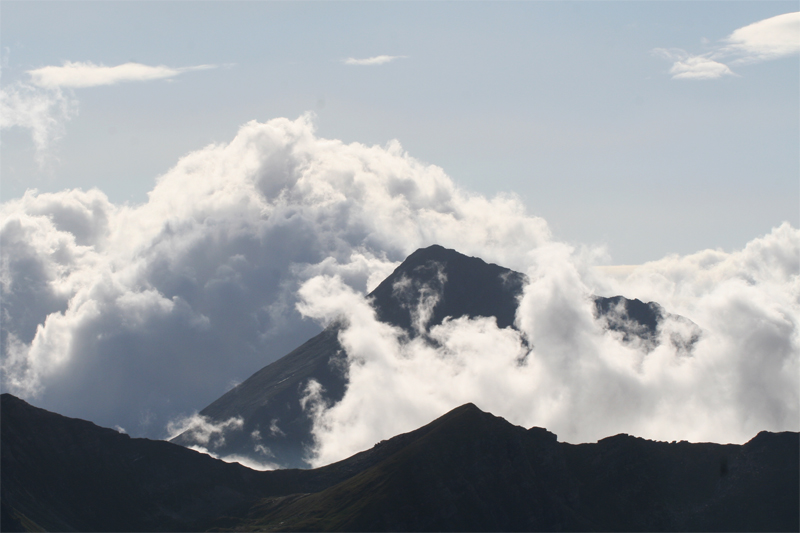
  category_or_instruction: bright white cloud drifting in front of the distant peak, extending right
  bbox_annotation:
[300,224,800,465]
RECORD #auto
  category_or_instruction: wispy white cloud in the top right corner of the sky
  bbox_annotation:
[653,12,800,80]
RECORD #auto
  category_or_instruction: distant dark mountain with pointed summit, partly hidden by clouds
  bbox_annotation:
[172,245,700,468]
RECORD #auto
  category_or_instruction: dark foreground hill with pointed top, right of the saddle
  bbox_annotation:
[209,404,800,531]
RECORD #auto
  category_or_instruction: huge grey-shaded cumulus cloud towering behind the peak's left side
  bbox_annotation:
[0,116,551,437]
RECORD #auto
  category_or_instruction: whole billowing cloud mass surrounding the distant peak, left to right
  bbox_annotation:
[0,116,800,464]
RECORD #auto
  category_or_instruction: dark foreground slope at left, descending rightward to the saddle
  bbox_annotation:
[0,394,272,531]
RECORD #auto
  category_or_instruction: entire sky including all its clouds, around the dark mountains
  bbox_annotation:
[0,1,800,464]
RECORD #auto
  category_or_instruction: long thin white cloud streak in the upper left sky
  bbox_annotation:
[28,61,216,89]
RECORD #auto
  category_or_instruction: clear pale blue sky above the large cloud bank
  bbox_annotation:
[0,1,800,264]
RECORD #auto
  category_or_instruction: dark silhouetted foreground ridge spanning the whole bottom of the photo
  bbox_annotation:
[0,394,800,531]
